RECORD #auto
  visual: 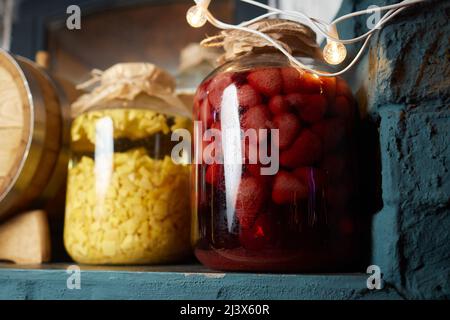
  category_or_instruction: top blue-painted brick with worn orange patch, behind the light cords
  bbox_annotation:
[360,1,450,107]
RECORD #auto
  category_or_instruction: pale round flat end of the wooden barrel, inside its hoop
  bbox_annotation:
[0,52,32,200]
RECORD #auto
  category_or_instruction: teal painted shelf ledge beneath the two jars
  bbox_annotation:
[0,264,401,300]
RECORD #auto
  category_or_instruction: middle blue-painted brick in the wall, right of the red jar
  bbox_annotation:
[379,102,450,206]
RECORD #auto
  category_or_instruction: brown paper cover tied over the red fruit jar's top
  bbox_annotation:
[201,19,323,63]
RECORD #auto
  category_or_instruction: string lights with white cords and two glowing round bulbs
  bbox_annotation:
[186,0,429,77]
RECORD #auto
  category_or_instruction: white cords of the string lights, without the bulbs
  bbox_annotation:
[194,0,428,77]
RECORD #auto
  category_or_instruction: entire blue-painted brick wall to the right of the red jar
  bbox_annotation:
[354,0,450,299]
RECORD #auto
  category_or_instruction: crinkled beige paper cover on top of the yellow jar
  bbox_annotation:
[72,63,191,118]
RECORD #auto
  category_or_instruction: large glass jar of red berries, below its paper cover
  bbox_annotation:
[192,53,358,272]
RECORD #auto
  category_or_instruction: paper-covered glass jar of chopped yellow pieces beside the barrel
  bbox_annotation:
[64,64,191,264]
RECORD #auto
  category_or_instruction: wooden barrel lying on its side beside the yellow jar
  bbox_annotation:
[0,50,70,219]
